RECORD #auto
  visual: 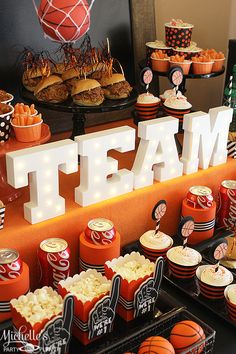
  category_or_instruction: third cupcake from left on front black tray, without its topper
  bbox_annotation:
[196,265,233,299]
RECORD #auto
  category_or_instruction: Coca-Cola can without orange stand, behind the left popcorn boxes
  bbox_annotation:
[38,238,70,289]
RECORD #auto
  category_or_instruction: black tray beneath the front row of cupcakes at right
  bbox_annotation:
[123,230,236,328]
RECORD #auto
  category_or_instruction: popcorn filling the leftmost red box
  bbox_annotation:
[11,286,63,326]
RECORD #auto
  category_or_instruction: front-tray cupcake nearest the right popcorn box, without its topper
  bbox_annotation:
[139,230,173,262]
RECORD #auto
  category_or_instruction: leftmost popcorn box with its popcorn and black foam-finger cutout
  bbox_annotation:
[11,286,74,354]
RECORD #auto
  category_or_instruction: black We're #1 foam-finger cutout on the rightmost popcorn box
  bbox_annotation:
[134,257,164,317]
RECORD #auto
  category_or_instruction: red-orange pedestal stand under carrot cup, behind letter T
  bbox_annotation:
[0,123,51,203]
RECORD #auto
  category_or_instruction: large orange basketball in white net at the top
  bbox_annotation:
[38,0,90,42]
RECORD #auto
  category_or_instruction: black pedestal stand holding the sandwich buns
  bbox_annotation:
[20,87,137,139]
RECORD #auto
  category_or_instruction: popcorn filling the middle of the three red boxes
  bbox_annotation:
[60,269,111,303]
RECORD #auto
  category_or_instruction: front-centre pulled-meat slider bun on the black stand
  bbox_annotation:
[71,79,104,106]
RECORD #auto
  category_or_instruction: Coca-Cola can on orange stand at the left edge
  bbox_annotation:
[0,248,23,282]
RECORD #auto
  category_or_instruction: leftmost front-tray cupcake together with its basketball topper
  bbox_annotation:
[139,200,173,262]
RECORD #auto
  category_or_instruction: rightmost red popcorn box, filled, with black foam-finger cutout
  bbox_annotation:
[105,252,164,321]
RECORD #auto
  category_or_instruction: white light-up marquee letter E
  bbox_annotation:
[75,126,135,206]
